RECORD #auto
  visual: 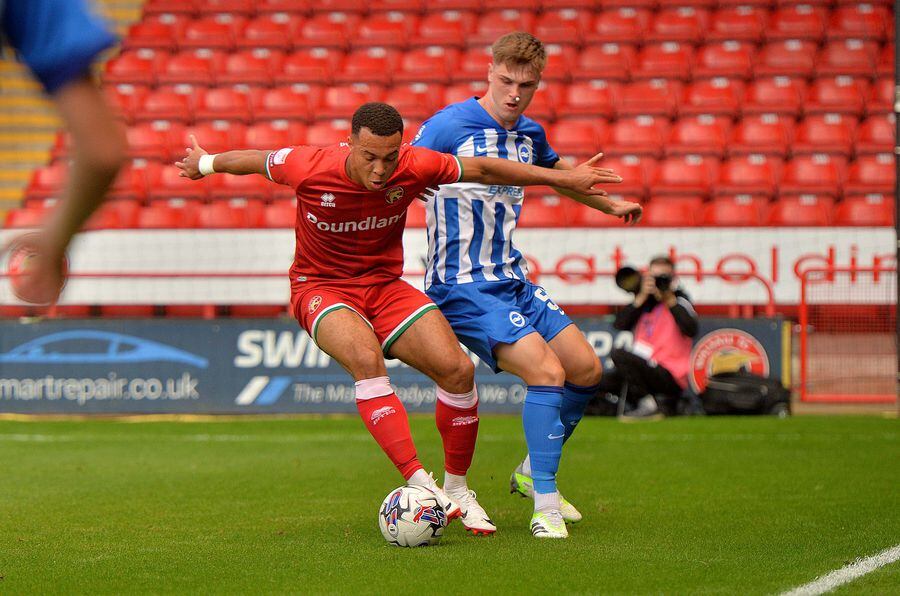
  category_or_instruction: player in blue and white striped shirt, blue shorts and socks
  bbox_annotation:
[413,32,641,538]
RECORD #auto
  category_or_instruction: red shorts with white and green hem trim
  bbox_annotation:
[291,279,437,354]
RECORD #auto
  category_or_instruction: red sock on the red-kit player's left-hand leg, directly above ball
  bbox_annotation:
[356,393,422,480]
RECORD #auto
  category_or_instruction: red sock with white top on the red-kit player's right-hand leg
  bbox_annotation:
[434,388,478,476]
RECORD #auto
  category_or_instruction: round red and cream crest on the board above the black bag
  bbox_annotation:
[688,328,769,393]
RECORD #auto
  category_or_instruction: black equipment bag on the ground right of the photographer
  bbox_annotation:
[700,371,791,416]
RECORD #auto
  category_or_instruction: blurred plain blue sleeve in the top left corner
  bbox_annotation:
[0,0,116,93]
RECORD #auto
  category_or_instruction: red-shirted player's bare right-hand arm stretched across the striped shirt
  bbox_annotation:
[459,153,622,197]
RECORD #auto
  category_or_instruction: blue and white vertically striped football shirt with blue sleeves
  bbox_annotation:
[413,97,559,288]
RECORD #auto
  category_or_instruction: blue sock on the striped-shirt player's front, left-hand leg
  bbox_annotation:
[522,385,565,494]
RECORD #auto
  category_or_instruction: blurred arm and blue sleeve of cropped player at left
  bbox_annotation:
[0,0,127,304]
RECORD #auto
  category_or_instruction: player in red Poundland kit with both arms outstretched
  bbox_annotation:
[175,103,620,534]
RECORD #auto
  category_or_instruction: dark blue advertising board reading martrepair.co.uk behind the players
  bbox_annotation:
[0,318,788,414]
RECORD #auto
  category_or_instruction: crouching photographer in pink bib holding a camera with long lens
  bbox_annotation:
[601,256,698,418]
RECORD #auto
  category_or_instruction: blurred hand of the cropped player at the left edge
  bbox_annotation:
[0,232,67,304]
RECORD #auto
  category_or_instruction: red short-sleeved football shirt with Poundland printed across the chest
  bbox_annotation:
[266,143,462,286]
